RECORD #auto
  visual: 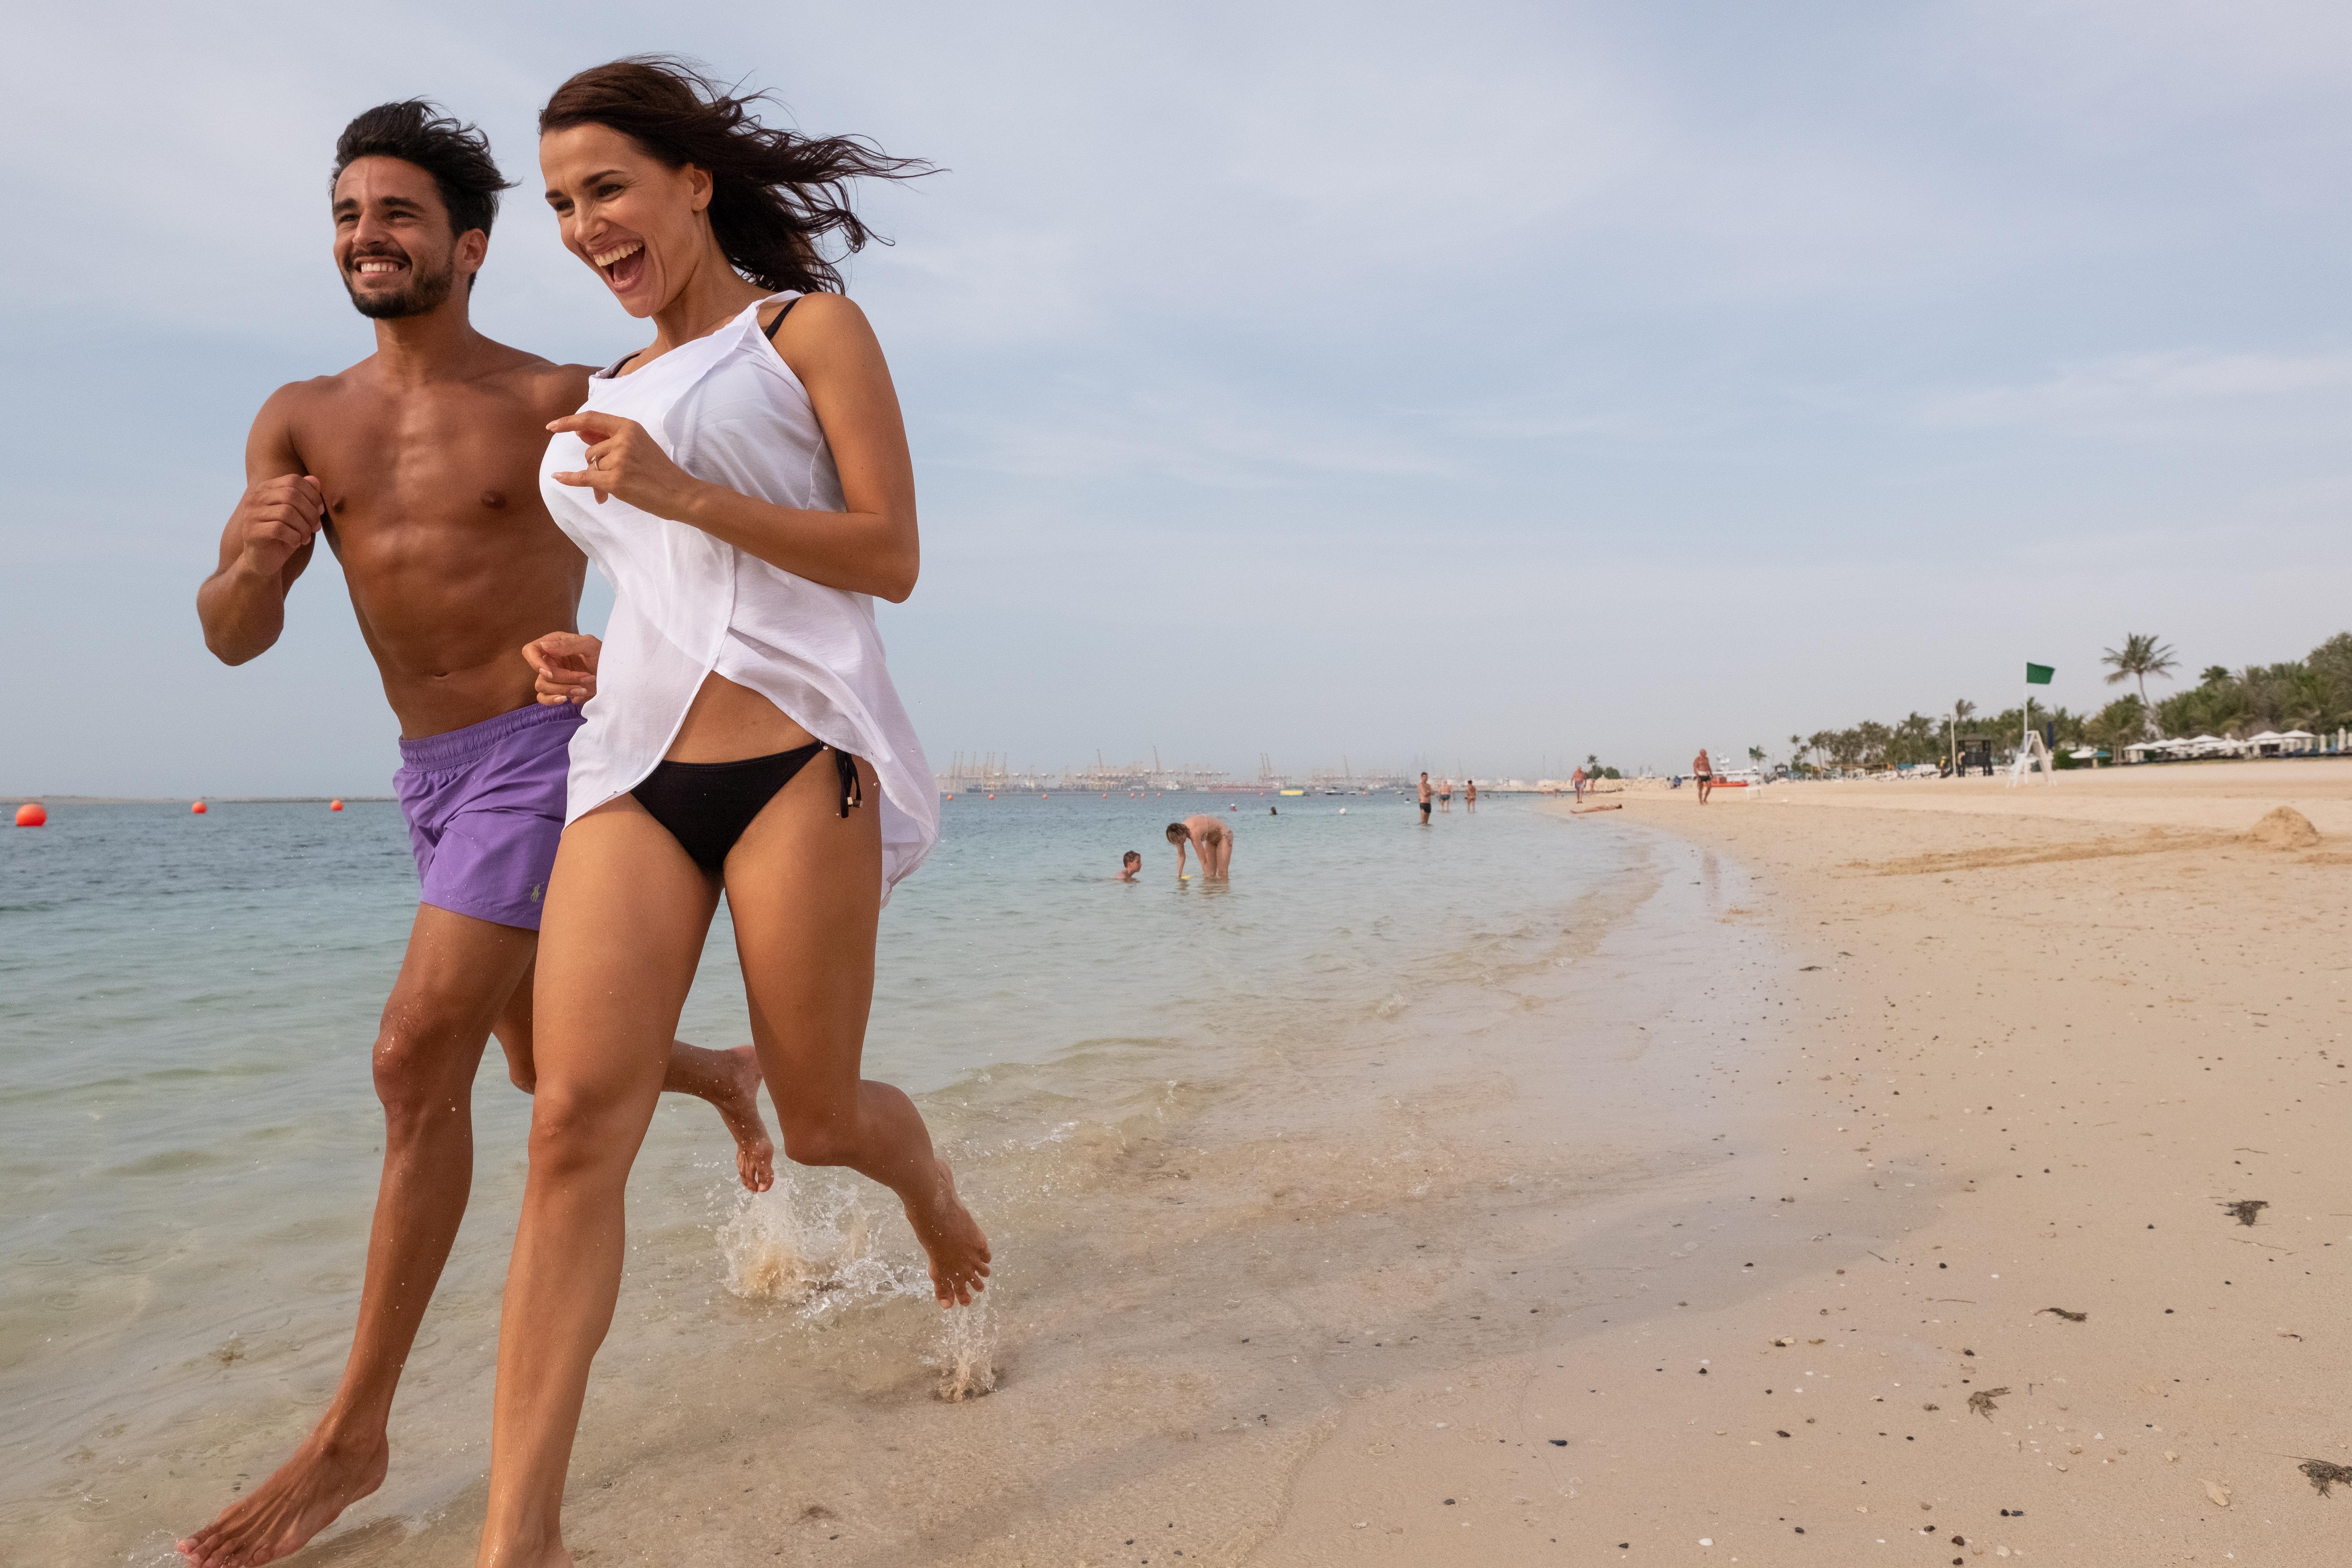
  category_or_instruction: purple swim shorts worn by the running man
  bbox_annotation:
[393,703,581,931]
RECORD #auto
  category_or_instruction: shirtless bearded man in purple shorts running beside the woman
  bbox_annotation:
[179,101,774,1568]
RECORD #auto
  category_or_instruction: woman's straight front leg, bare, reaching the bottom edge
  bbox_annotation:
[477,797,717,1568]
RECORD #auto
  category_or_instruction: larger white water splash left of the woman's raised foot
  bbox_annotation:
[720,1171,931,1323]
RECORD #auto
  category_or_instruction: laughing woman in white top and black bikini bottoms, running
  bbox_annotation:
[480,59,988,1568]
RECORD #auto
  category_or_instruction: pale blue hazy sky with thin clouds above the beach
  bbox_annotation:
[0,0,2352,795]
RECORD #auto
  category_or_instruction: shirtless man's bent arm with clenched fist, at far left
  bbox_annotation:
[195,386,327,665]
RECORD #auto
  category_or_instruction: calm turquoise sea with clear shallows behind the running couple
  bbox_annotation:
[0,792,1712,1561]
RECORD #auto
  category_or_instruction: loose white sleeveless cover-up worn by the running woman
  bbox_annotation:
[539,294,938,900]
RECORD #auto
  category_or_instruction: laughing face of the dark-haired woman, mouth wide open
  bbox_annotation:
[539,125,710,318]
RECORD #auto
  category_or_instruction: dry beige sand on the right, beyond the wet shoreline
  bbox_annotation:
[1289,762,2352,1563]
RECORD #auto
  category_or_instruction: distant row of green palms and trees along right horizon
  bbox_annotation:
[1788,632,2352,773]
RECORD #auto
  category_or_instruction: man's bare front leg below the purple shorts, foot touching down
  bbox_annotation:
[179,905,536,1568]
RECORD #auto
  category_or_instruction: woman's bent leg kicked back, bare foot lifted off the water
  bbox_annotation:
[727,755,988,1307]
